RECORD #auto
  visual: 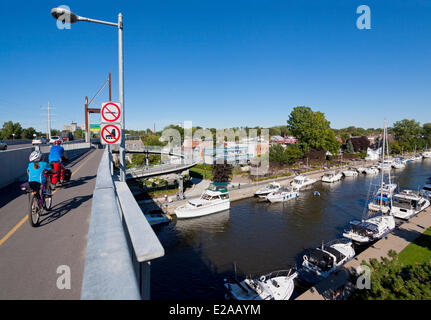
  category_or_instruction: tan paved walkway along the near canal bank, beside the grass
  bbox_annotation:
[296,207,431,300]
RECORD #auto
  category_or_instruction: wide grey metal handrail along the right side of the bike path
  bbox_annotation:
[81,148,165,300]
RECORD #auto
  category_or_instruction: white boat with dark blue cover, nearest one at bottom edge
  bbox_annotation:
[224,270,298,300]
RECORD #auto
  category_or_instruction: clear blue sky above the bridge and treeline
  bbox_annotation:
[0,0,431,129]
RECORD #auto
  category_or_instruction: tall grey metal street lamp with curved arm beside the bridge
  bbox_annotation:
[51,7,126,182]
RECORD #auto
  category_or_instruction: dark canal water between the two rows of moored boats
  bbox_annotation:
[151,159,431,300]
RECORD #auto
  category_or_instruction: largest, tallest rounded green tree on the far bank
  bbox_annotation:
[287,106,340,154]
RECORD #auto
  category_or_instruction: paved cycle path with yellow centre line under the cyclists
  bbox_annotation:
[0,149,103,300]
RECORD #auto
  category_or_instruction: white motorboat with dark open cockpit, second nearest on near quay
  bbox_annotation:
[299,239,355,283]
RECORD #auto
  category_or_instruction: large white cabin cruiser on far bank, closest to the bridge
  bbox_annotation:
[174,182,230,219]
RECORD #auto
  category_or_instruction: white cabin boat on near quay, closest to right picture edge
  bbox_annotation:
[391,190,430,220]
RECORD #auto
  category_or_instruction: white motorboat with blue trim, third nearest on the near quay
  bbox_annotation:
[343,215,395,244]
